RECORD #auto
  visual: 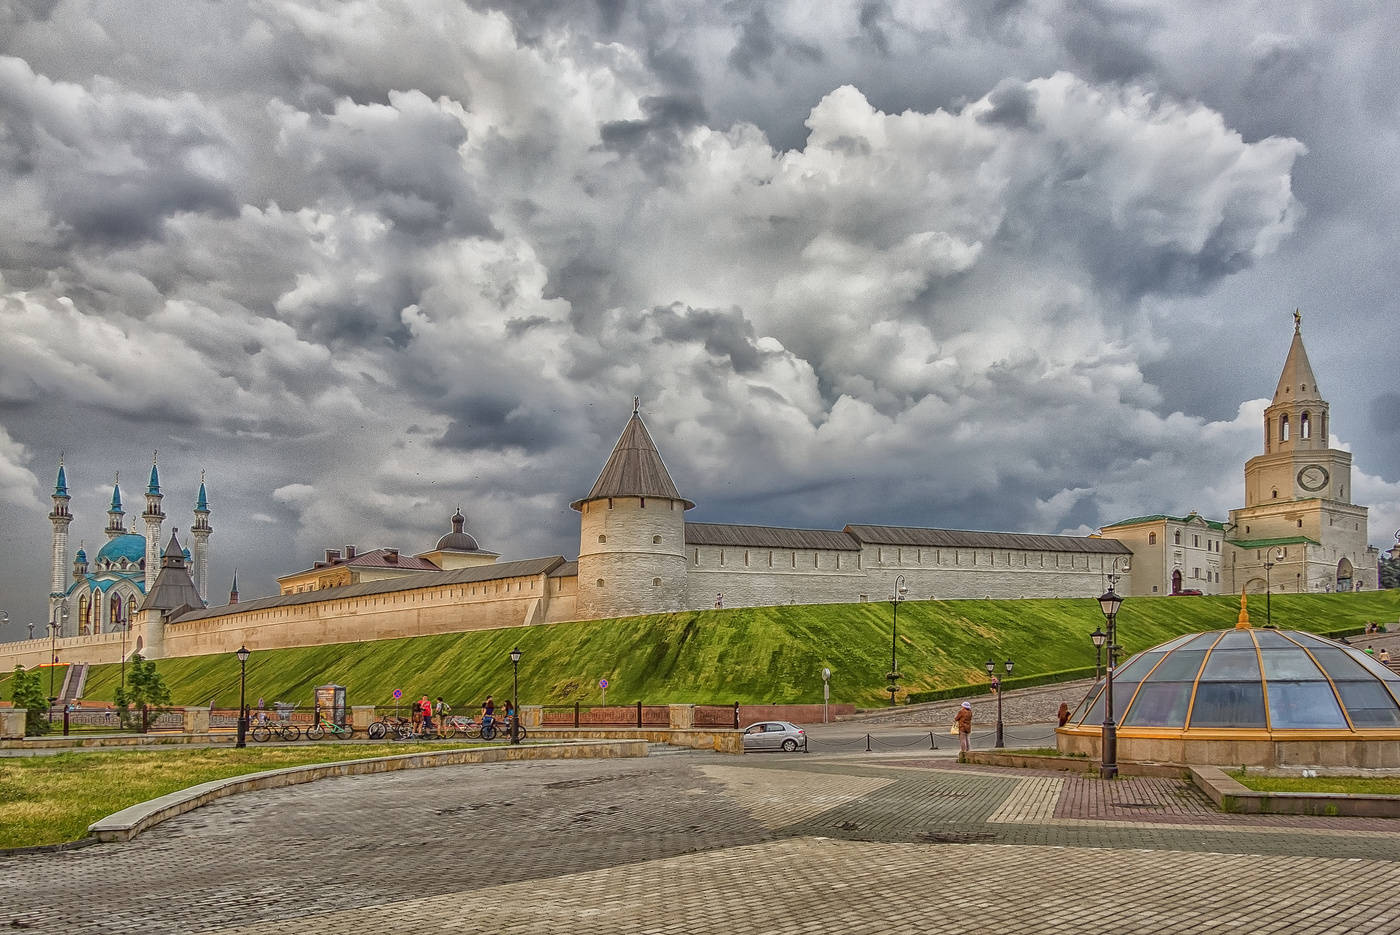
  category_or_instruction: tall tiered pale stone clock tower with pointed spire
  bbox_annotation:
[1226,312,1379,592]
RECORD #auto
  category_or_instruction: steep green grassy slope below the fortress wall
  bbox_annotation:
[73,591,1400,707]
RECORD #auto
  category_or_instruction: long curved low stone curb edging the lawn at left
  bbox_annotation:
[88,740,647,848]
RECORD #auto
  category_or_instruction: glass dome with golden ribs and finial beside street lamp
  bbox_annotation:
[1070,627,1400,732]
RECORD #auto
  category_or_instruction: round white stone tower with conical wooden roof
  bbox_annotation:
[570,399,694,619]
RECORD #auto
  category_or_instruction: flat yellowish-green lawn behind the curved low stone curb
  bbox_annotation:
[0,743,444,848]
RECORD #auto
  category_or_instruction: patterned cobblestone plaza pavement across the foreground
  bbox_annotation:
[8,753,1400,935]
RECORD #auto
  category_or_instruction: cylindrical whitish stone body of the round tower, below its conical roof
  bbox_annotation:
[577,497,686,620]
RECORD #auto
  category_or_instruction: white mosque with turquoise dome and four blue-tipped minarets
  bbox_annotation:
[49,456,214,637]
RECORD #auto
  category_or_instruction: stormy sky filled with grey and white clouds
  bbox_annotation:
[0,0,1400,637]
